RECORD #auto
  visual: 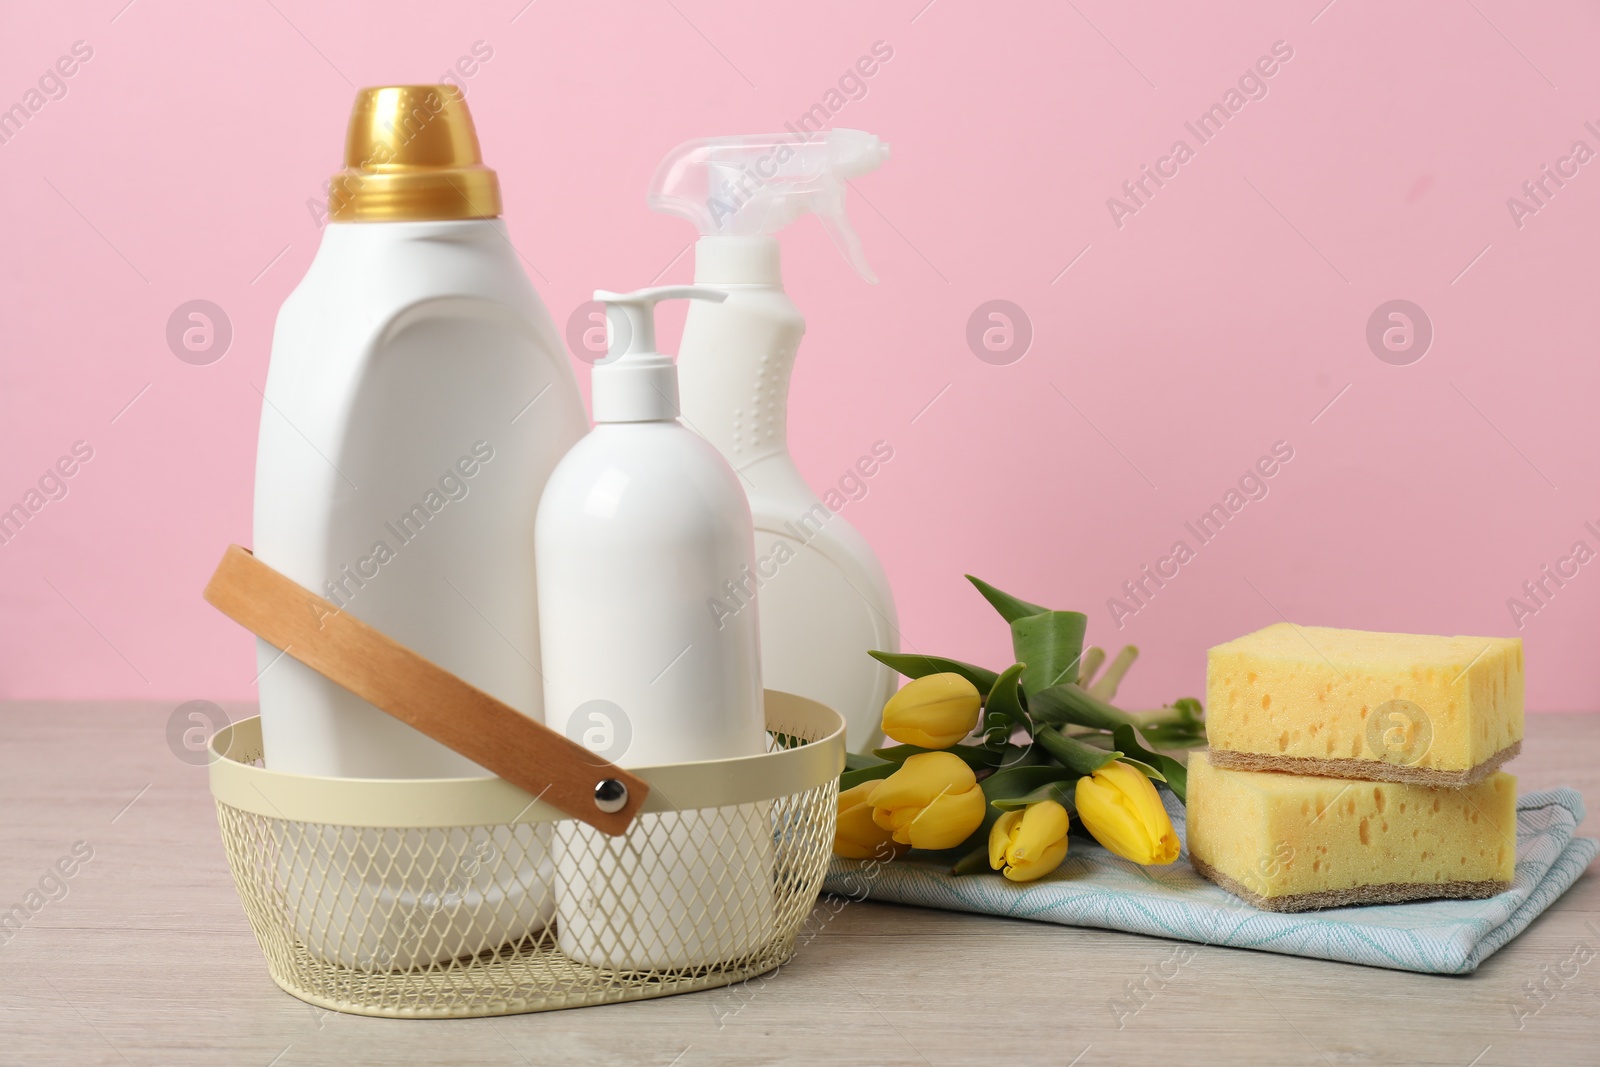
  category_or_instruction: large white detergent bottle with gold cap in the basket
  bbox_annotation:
[254,85,586,969]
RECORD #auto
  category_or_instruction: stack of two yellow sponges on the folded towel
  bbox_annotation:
[1189,622,1523,912]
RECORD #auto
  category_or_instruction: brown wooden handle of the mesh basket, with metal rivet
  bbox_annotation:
[205,544,650,837]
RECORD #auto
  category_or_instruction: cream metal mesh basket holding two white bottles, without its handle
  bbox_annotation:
[211,691,845,1017]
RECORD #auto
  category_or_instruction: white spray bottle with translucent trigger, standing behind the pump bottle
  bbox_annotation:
[650,130,899,752]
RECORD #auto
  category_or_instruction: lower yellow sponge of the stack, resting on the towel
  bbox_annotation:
[1189,752,1517,912]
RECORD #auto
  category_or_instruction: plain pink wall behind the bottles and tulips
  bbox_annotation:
[0,0,1600,710]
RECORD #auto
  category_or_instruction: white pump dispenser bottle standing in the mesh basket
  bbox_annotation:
[536,286,773,971]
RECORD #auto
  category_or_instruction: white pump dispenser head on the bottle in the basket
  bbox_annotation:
[592,285,728,422]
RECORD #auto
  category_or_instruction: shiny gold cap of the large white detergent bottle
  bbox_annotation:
[328,85,501,222]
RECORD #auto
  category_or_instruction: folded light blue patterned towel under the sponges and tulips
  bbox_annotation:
[822,789,1600,974]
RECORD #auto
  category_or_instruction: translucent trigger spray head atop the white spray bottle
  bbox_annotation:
[648,130,890,282]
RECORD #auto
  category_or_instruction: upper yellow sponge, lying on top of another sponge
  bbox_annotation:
[1206,622,1523,785]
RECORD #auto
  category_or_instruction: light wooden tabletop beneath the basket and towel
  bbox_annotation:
[0,704,1600,1067]
